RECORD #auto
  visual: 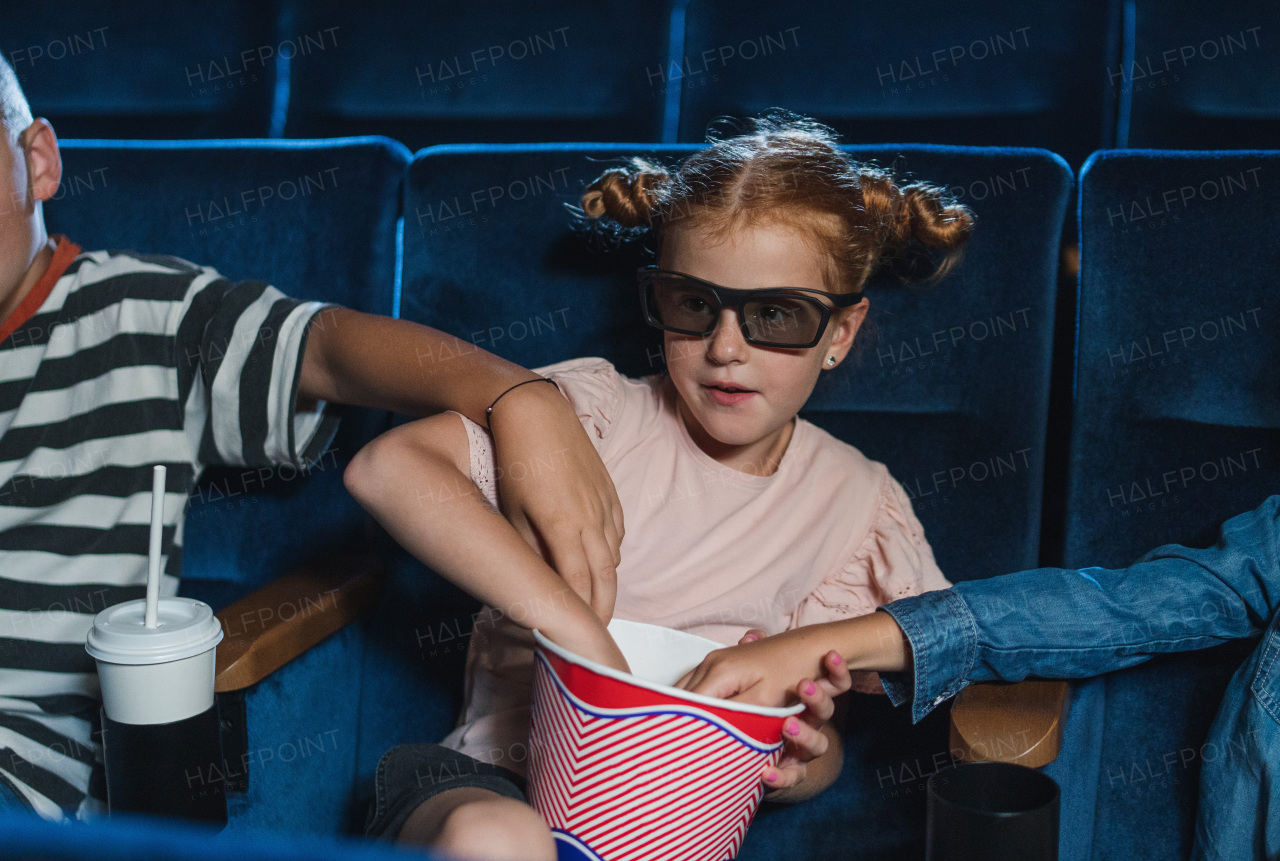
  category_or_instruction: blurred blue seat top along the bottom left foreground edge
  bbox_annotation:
[0,814,435,861]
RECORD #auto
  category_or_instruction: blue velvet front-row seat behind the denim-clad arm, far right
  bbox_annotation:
[1065,150,1280,860]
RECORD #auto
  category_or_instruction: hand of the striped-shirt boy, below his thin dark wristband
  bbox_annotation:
[489,383,623,622]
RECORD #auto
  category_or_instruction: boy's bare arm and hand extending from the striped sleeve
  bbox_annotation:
[298,307,623,619]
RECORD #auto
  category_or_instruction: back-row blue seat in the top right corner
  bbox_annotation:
[1107,0,1280,150]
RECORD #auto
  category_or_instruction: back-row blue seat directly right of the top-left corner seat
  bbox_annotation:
[288,0,668,148]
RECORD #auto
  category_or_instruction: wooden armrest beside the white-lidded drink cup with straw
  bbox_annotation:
[214,553,383,693]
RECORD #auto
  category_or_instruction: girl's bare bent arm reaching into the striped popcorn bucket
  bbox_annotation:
[343,409,626,669]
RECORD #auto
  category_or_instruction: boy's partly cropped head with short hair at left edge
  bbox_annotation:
[0,58,63,322]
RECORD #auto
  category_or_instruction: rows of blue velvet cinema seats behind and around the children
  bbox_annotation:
[0,0,1280,861]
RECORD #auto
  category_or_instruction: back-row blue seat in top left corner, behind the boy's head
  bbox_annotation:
[0,0,280,138]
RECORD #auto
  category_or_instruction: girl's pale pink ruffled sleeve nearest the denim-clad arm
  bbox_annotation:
[788,470,951,693]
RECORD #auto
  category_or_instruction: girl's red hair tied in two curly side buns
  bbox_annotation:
[581,115,973,292]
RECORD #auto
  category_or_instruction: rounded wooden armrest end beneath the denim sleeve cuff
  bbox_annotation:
[951,679,1068,768]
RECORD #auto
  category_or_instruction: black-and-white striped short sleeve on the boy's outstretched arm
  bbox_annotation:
[175,270,338,468]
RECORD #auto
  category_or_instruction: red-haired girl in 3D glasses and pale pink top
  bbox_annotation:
[347,118,973,861]
